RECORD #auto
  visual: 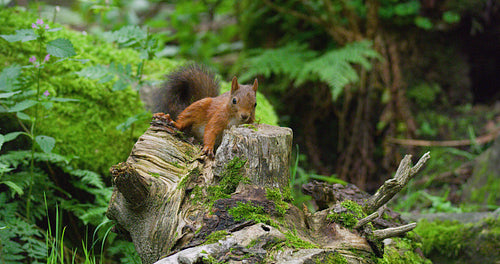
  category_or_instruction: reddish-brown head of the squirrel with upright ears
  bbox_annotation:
[229,76,259,123]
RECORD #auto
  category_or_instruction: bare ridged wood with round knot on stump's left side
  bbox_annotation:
[106,120,206,263]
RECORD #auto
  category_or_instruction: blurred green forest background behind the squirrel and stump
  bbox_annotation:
[0,0,500,263]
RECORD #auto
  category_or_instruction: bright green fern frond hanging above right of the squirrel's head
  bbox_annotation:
[240,41,381,100]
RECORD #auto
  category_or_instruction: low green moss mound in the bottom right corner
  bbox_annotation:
[415,218,500,263]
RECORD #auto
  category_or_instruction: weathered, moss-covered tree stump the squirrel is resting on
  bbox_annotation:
[107,114,430,264]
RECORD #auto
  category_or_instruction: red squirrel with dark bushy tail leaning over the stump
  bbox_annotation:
[155,64,258,158]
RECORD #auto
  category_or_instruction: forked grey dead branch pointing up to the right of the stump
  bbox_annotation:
[363,152,431,214]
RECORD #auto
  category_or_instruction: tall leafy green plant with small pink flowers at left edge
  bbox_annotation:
[0,19,77,220]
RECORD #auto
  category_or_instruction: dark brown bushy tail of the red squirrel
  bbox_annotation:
[153,63,219,119]
